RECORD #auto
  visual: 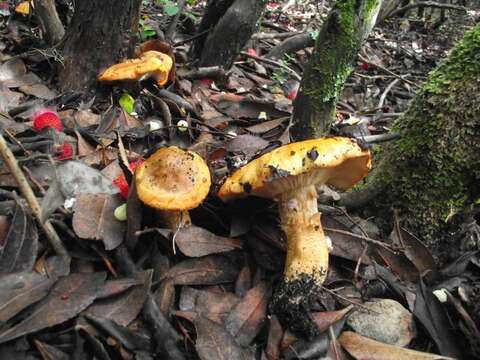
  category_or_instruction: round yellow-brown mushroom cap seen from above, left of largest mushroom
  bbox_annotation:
[135,146,211,210]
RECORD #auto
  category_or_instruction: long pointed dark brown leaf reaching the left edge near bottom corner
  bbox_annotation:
[0,273,106,343]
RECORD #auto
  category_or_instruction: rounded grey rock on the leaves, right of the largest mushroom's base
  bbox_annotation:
[347,299,416,346]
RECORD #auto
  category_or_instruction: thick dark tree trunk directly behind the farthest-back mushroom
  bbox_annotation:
[60,0,142,91]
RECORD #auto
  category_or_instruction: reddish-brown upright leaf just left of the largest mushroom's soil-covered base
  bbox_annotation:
[225,282,271,346]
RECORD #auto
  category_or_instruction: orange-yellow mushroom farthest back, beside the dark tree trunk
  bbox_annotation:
[98,50,173,86]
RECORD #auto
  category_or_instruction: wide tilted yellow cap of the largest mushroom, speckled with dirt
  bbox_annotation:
[218,137,371,199]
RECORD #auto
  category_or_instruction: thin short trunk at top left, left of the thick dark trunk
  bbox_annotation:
[35,0,65,46]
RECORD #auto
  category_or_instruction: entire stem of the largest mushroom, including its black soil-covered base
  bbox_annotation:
[272,186,328,338]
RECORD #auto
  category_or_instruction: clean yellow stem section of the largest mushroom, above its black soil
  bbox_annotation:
[278,185,328,285]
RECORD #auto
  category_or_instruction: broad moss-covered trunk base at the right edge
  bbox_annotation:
[354,25,480,257]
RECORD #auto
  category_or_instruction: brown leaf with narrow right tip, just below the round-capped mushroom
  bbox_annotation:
[175,225,242,257]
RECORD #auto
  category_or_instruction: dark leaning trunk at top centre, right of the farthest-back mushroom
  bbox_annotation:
[193,0,266,69]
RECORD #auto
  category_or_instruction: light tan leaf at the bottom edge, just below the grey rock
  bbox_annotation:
[338,331,453,360]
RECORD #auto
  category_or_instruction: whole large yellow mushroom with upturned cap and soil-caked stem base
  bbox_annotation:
[218,137,371,336]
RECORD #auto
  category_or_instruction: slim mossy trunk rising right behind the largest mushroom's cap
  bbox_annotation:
[292,0,381,140]
